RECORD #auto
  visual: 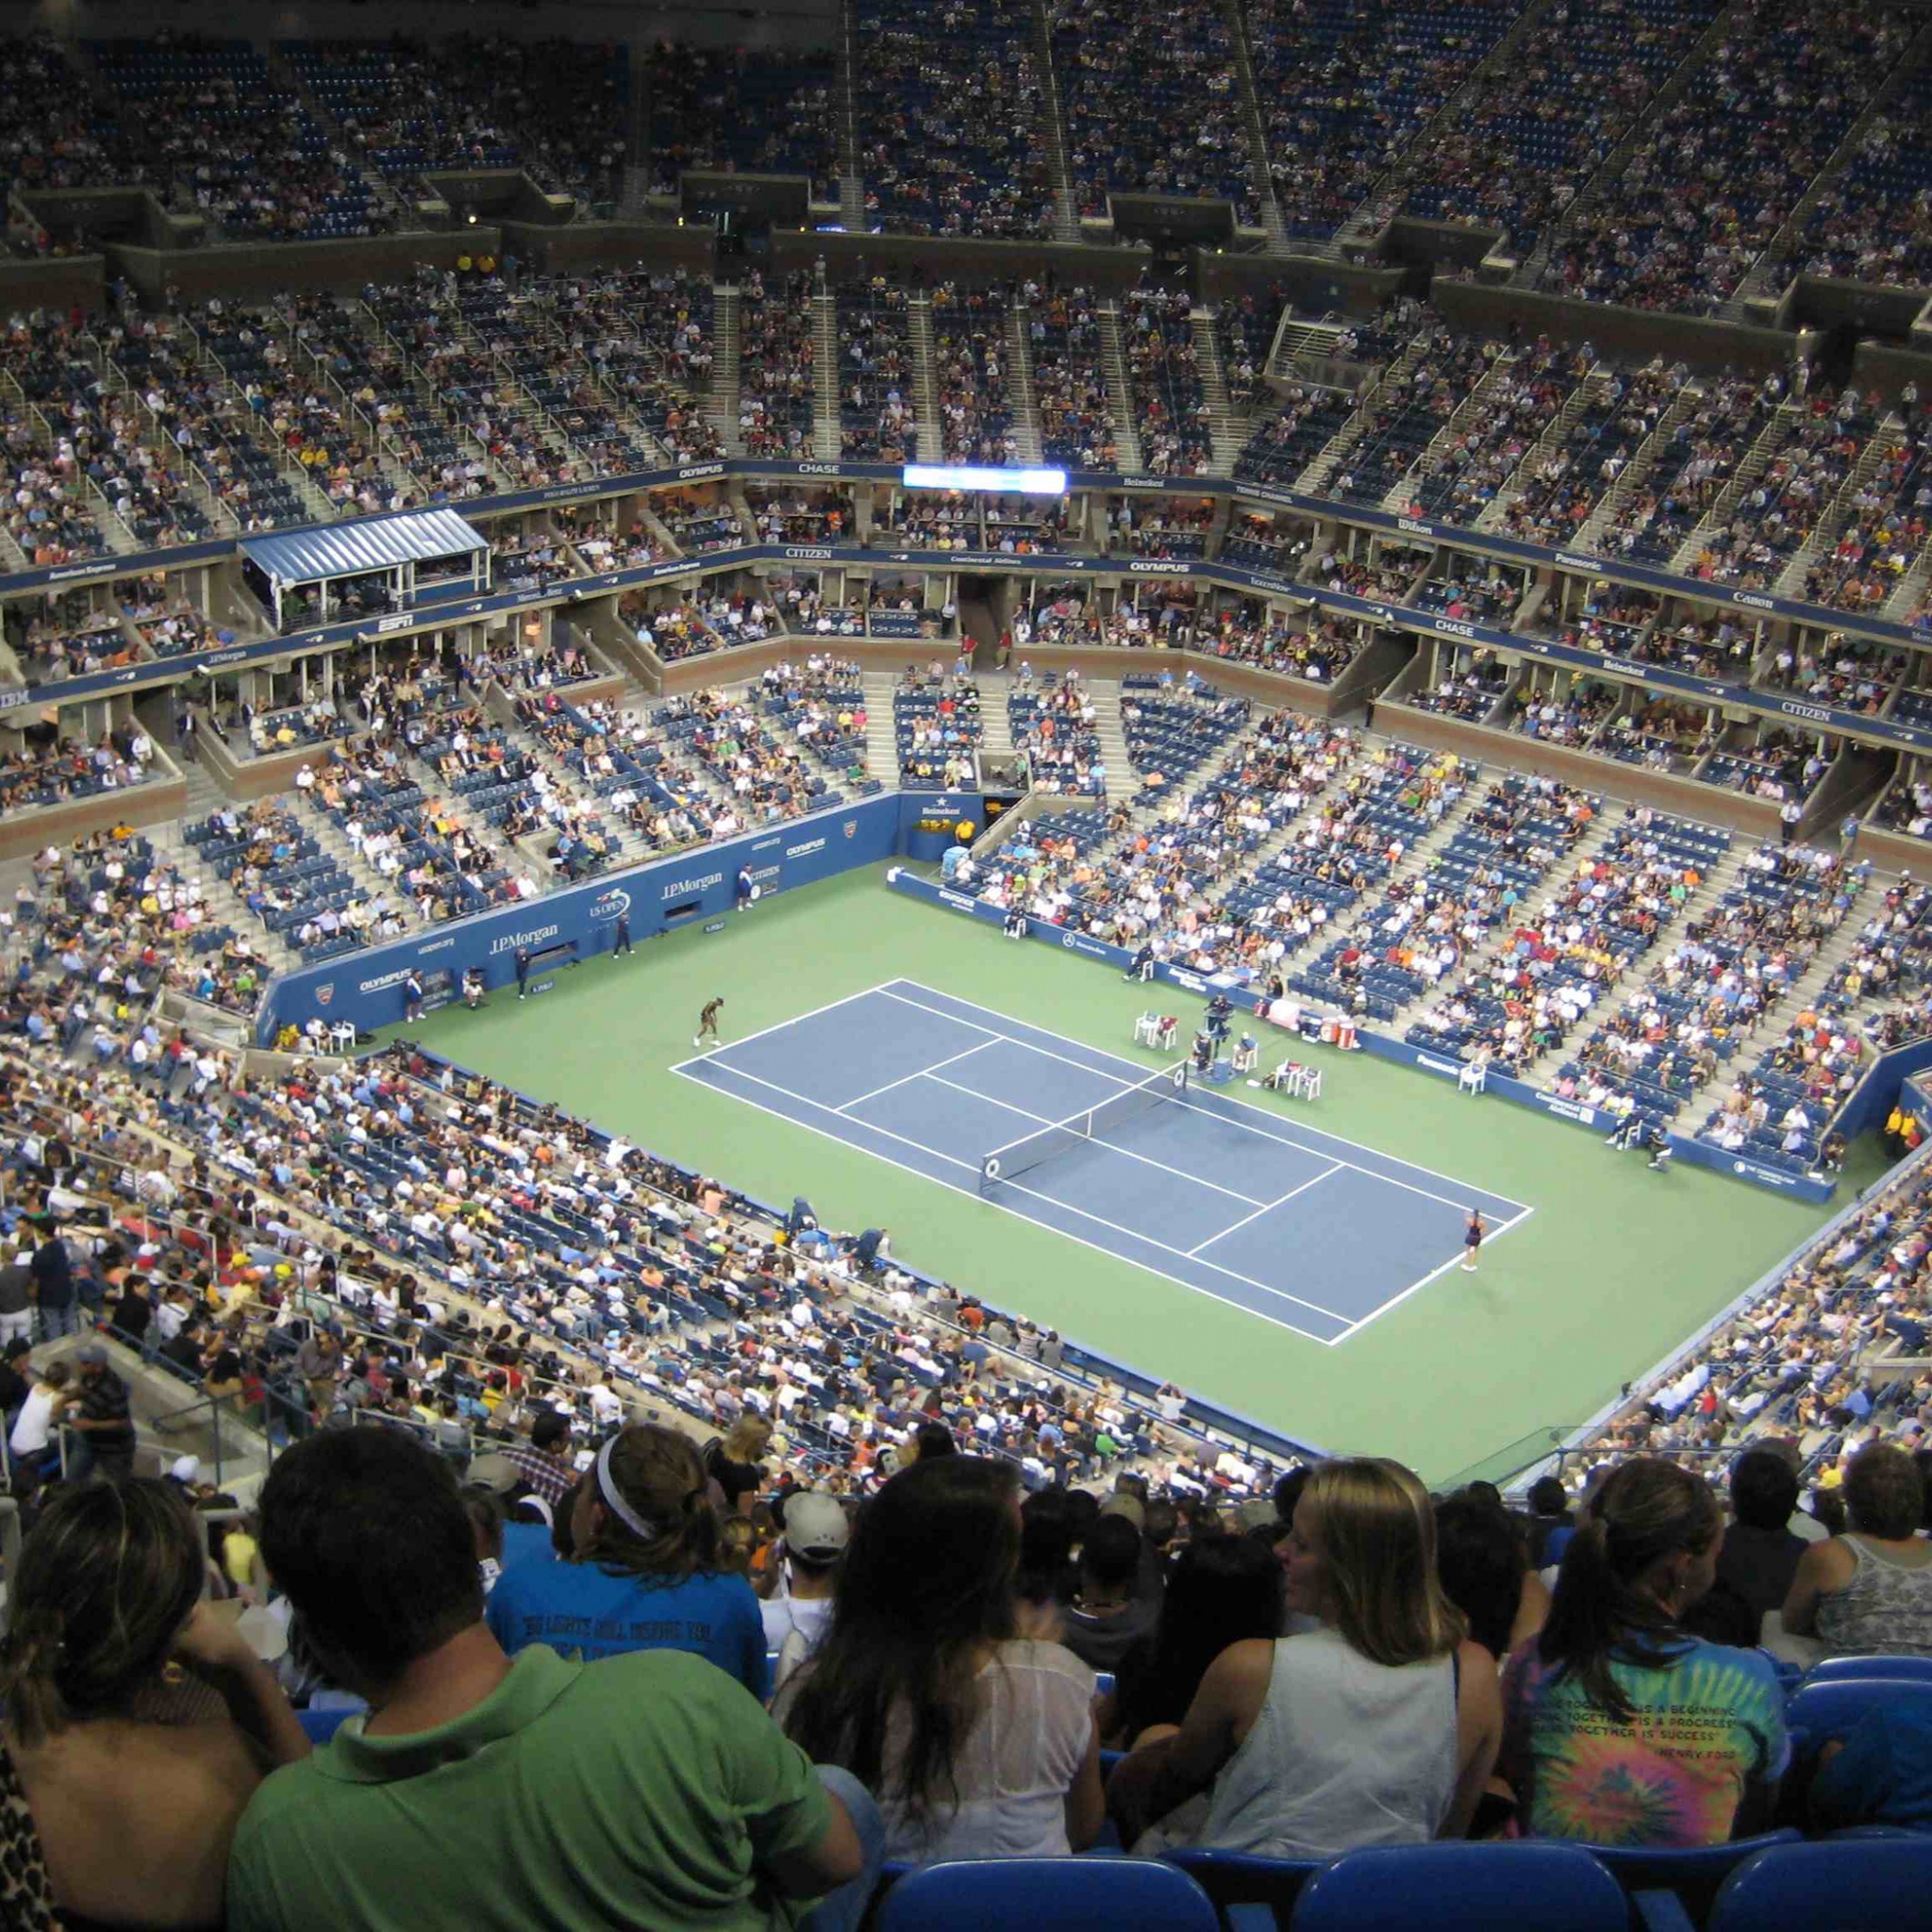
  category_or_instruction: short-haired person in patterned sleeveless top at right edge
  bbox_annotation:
[1785,1443,1932,1657]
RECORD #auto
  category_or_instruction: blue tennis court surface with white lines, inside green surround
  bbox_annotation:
[676,979,1530,1342]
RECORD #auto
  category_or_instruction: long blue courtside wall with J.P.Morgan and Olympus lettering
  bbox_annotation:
[255,792,958,1045]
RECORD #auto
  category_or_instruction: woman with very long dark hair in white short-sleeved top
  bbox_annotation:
[774,1455,1103,1864]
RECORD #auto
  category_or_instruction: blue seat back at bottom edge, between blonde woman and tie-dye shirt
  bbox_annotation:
[1291,1841,1631,1932]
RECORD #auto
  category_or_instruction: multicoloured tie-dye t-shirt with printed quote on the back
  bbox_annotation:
[1499,1639,1790,1845]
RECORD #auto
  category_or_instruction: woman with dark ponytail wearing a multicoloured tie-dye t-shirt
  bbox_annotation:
[1501,1457,1790,1845]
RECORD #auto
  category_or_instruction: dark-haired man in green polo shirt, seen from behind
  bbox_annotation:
[228,1430,877,1932]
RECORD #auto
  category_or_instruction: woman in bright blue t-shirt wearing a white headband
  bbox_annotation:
[489,1424,771,1702]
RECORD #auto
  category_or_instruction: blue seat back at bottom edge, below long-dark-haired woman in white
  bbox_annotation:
[877,1858,1213,1932]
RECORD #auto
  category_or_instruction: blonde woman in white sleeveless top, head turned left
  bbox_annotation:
[1109,1458,1501,1858]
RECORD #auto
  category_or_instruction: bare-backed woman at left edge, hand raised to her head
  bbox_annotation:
[0,1482,309,1932]
